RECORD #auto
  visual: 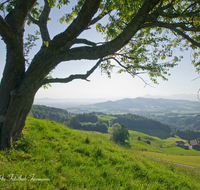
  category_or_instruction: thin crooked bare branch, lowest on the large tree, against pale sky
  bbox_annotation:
[42,59,103,85]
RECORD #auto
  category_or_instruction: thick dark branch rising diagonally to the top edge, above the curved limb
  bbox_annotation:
[49,0,101,50]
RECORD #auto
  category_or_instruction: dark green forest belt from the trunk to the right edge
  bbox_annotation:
[29,105,200,140]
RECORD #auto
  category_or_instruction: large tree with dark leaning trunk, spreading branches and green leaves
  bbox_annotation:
[0,0,200,149]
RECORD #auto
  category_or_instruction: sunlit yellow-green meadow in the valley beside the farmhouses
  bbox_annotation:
[130,131,200,167]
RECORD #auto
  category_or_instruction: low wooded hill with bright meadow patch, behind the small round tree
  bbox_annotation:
[29,105,171,138]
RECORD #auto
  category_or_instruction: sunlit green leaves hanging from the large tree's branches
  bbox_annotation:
[0,0,200,83]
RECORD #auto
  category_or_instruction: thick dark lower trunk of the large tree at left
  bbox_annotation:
[0,44,42,149]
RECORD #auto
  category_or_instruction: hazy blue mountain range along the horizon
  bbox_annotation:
[66,98,200,115]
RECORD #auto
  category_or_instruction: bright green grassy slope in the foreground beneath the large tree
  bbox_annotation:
[0,118,200,190]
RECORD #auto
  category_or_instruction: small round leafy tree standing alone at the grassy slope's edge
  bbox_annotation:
[110,123,129,143]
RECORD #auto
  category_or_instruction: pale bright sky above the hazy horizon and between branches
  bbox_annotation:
[0,1,200,101]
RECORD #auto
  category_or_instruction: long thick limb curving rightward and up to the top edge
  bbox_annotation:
[59,0,159,61]
